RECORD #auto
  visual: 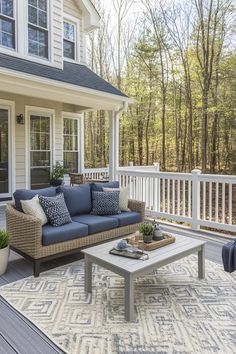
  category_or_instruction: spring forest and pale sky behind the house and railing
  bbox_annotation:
[85,0,236,174]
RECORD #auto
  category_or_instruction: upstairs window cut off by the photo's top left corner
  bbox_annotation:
[0,0,15,49]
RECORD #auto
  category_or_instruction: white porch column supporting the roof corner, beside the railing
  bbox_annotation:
[109,111,119,181]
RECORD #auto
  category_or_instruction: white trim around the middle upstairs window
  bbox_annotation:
[25,0,53,64]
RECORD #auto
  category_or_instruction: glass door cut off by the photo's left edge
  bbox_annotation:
[0,107,10,199]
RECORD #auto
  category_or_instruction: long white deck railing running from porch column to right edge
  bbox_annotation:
[117,168,236,232]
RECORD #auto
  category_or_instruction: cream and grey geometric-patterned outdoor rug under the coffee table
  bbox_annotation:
[0,255,236,354]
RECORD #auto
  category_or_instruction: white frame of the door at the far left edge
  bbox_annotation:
[0,98,16,200]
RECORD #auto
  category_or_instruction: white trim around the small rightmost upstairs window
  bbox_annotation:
[62,13,80,63]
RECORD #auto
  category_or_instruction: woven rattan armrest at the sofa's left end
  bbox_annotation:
[6,204,42,259]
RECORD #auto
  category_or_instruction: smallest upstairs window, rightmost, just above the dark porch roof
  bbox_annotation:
[63,21,76,60]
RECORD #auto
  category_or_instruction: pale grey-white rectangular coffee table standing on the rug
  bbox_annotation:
[82,235,206,321]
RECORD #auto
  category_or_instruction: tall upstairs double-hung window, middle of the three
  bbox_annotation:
[28,0,48,58]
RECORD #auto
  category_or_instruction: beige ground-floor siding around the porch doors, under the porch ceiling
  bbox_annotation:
[0,92,79,189]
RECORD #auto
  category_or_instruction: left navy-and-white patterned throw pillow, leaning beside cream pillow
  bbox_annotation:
[39,193,72,226]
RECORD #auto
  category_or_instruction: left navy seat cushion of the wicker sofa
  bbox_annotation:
[42,222,88,246]
